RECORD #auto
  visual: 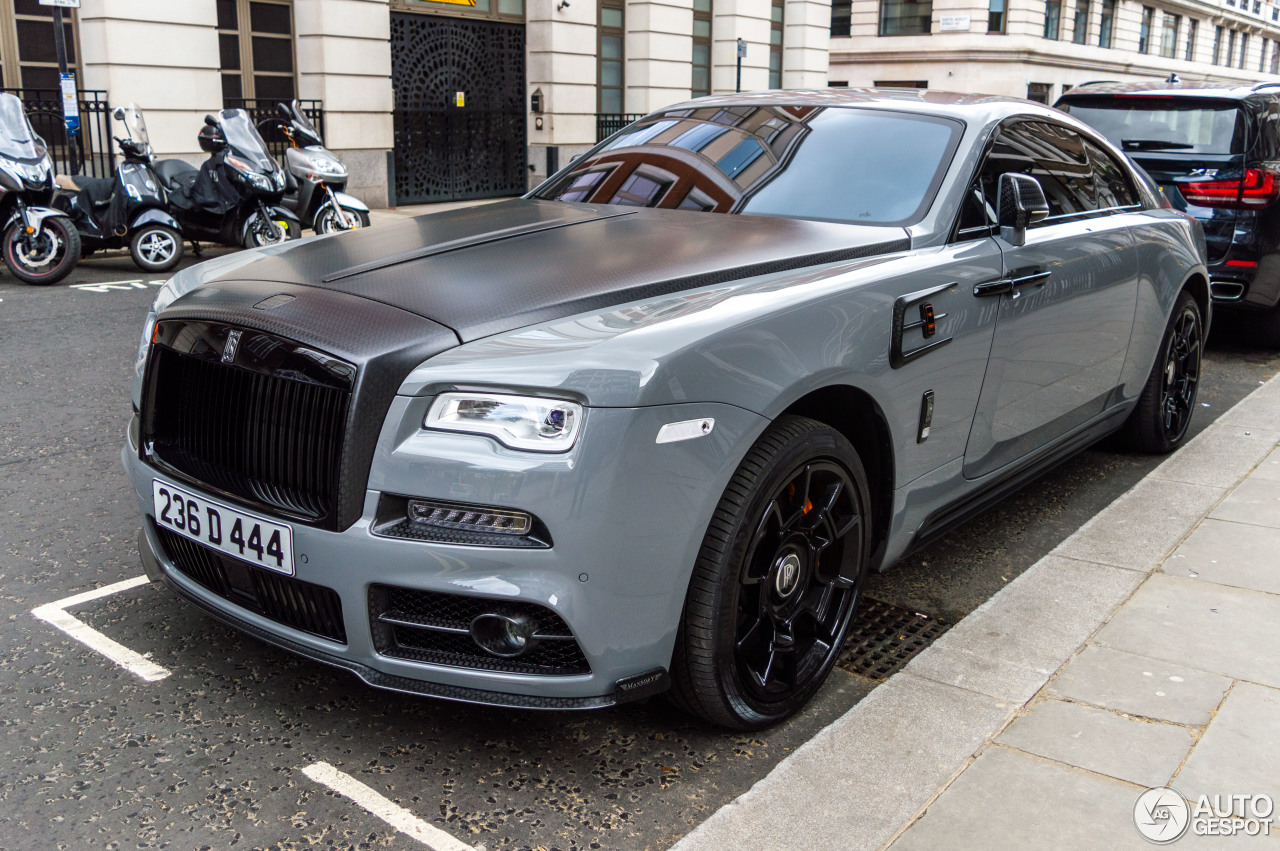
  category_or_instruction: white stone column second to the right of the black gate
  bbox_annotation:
[626,0,694,113]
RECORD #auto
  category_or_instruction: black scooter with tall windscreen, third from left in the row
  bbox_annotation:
[152,109,302,250]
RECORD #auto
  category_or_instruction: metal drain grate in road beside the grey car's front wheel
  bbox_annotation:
[836,598,951,680]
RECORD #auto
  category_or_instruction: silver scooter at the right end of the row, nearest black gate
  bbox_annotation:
[260,100,369,233]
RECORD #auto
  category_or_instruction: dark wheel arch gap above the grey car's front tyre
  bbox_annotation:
[780,384,893,569]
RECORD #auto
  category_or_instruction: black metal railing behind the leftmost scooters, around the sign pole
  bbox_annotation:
[0,88,115,178]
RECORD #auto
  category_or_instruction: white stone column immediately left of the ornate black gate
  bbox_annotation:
[293,0,396,207]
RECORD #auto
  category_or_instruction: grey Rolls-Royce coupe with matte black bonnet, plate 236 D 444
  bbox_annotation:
[123,90,1210,728]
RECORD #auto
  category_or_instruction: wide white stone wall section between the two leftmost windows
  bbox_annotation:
[79,0,223,163]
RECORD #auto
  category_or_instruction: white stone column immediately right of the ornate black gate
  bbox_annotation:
[525,0,599,182]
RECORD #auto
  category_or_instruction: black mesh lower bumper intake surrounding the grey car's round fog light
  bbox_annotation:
[369,585,591,676]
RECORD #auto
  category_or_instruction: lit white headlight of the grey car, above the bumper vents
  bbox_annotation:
[422,393,582,452]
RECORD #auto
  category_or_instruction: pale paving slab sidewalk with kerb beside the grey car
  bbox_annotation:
[673,376,1280,851]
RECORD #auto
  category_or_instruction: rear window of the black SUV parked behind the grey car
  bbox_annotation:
[1059,95,1244,154]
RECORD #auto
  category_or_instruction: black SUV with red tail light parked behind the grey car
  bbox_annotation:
[1056,82,1280,347]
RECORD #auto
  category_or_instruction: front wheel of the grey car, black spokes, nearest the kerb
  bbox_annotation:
[672,416,870,729]
